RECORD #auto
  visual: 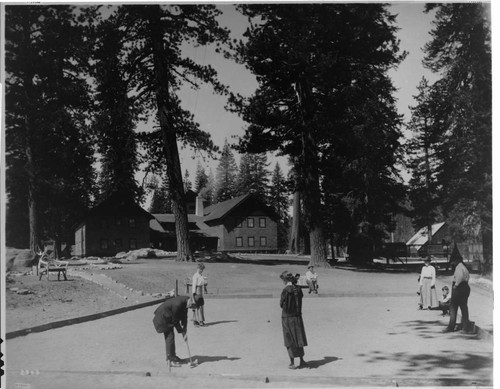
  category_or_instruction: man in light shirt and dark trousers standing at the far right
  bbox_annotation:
[443,254,470,332]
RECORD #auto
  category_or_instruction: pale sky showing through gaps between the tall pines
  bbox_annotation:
[164,2,435,186]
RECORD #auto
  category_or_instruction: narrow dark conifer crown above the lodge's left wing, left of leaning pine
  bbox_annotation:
[93,13,142,201]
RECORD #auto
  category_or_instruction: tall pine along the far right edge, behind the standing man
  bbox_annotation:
[418,2,493,271]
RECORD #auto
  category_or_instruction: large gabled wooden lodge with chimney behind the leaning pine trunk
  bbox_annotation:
[73,191,278,257]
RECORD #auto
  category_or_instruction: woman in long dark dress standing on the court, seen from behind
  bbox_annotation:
[280,271,308,369]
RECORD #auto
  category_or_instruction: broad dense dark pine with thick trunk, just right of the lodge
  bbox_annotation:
[233,4,404,266]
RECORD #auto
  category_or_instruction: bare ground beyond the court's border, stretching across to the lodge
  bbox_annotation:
[5,249,491,332]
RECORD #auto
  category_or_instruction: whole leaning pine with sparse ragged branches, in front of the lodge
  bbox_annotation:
[106,4,228,260]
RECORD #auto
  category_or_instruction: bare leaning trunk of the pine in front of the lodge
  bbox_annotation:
[146,5,193,261]
